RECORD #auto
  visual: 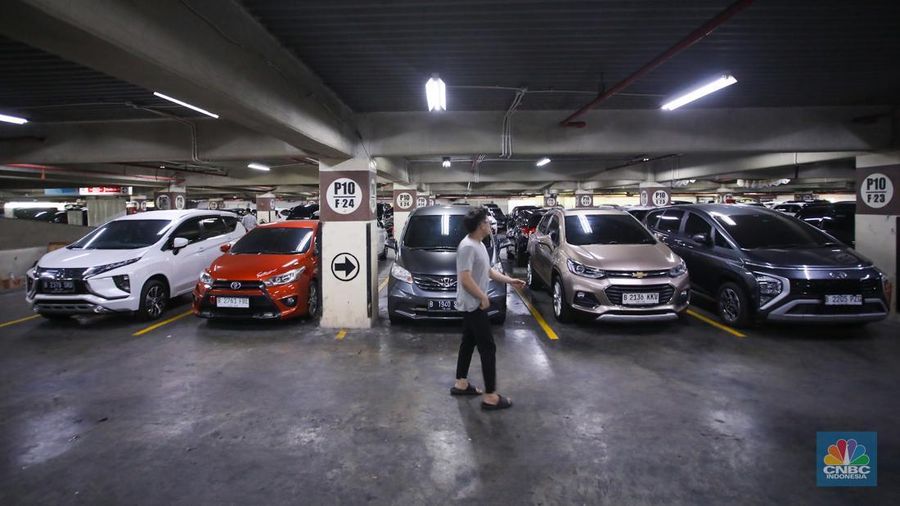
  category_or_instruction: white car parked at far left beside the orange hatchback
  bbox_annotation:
[26,209,246,320]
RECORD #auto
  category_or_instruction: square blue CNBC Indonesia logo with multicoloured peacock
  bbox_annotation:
[816,432,877,487]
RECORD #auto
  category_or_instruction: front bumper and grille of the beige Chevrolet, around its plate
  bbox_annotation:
[566,274,691,322]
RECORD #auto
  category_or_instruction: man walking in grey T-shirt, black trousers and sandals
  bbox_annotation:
[450,207,525,410]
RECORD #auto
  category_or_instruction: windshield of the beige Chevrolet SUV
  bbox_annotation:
[566,214,656,246]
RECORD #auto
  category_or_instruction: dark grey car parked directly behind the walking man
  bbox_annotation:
[388,205,506,323]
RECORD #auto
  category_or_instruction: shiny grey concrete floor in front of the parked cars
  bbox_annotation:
[0,258,900,505]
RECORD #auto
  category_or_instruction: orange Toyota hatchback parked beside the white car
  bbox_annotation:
[194,220,321,319]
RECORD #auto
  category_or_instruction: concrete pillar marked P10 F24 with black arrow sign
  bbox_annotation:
[319,158,378,328]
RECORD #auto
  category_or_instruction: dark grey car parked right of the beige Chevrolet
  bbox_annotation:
[645,204,890,326]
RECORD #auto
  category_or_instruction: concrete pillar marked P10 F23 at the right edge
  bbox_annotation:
[856,152,900,319]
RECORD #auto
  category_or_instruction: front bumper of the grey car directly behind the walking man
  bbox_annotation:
[388,277,506,320]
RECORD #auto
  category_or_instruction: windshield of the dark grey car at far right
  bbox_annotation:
[711,212,836,249]
